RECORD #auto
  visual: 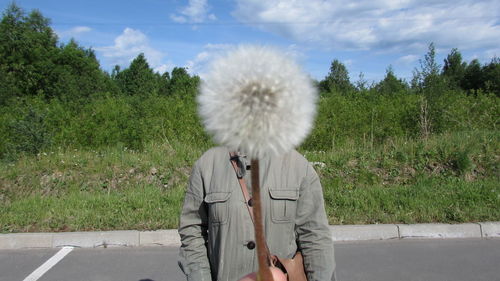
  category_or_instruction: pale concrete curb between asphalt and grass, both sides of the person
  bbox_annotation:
[0,222,500,250]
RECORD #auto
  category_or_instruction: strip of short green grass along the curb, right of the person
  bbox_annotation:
[325,178,500,224]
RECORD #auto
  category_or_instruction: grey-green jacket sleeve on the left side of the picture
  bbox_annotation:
[179,164,212,281]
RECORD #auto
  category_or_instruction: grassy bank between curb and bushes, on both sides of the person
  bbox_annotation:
[0,131,500,233]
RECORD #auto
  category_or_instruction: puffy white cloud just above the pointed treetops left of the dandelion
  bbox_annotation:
[95,27,168,69]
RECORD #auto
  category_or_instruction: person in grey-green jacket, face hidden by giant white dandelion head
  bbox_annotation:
[179,45,335,281]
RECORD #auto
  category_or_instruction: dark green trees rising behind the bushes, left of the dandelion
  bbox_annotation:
[0,4,199,105]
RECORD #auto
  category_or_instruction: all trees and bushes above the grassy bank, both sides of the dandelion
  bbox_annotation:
[0,4,500,159]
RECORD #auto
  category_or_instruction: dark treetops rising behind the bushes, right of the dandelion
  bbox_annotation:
[318,43,500,96]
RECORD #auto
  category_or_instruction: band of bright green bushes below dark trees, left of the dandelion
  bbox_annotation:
[0,94,210,158]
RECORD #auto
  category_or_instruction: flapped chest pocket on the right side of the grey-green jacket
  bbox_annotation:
[269,188,299,223]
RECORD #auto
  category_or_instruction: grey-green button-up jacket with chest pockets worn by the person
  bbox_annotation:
[179,147,335,281]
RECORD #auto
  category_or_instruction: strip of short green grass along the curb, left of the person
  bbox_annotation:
[2,184,184,232]
